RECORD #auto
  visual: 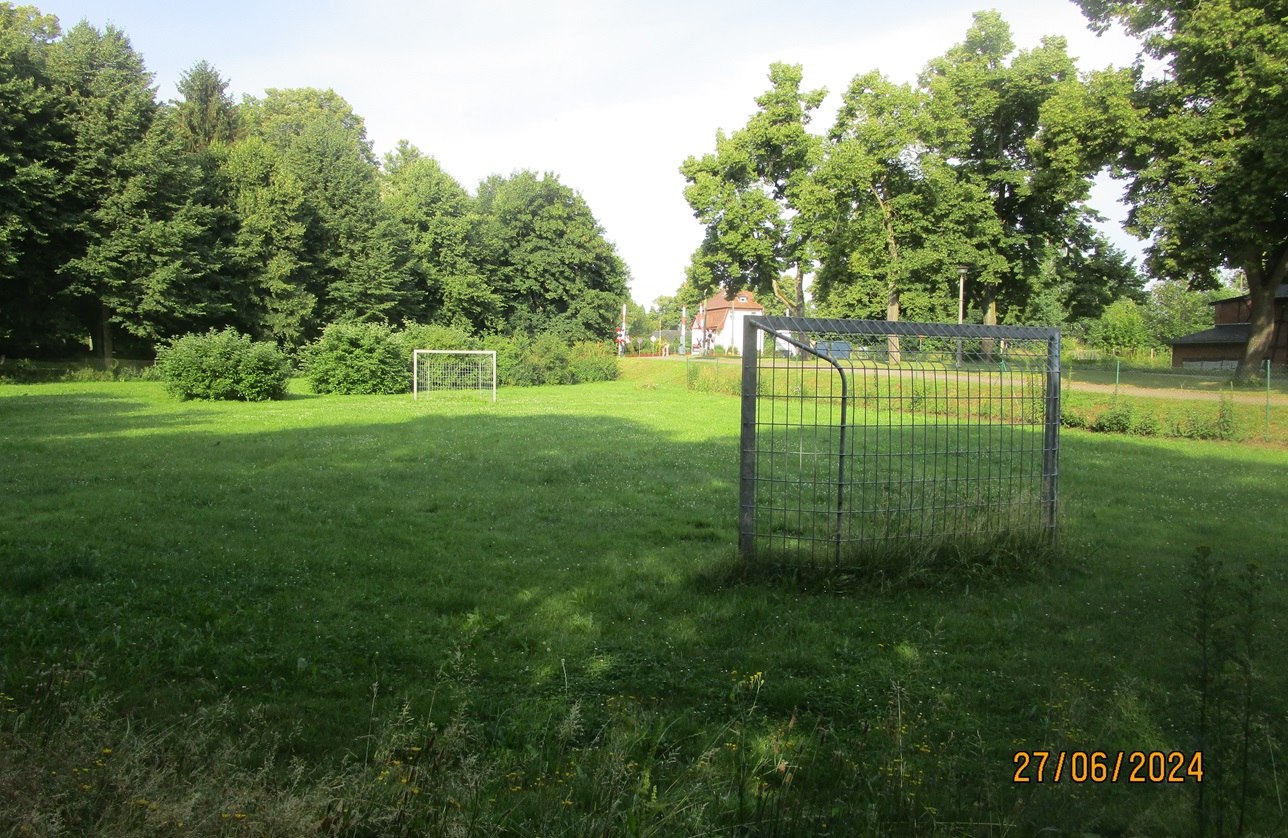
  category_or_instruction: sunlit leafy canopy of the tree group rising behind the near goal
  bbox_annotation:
[680,12,1141,332]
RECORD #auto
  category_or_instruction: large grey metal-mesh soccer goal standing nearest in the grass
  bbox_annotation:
[738,317,1060,568]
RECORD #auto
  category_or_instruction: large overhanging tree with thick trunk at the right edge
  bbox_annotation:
[1079,0,1288,378]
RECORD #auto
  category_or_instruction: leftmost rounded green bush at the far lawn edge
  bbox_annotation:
[156,327,291,402]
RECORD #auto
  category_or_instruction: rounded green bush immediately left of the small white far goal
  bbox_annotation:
[301,323,401,395]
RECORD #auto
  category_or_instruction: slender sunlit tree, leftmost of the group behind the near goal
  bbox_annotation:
[680,63,827,314]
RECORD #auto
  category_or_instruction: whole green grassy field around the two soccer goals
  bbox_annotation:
[0,360,1288,835]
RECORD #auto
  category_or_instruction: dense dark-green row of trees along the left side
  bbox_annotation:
[0,3,627,359]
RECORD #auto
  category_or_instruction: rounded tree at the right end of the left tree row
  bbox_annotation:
[474,171,627,340]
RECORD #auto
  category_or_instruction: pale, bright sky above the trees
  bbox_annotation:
[45,0,1140,305]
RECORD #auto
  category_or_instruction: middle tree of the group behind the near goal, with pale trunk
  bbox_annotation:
[813,72,1005,328]
